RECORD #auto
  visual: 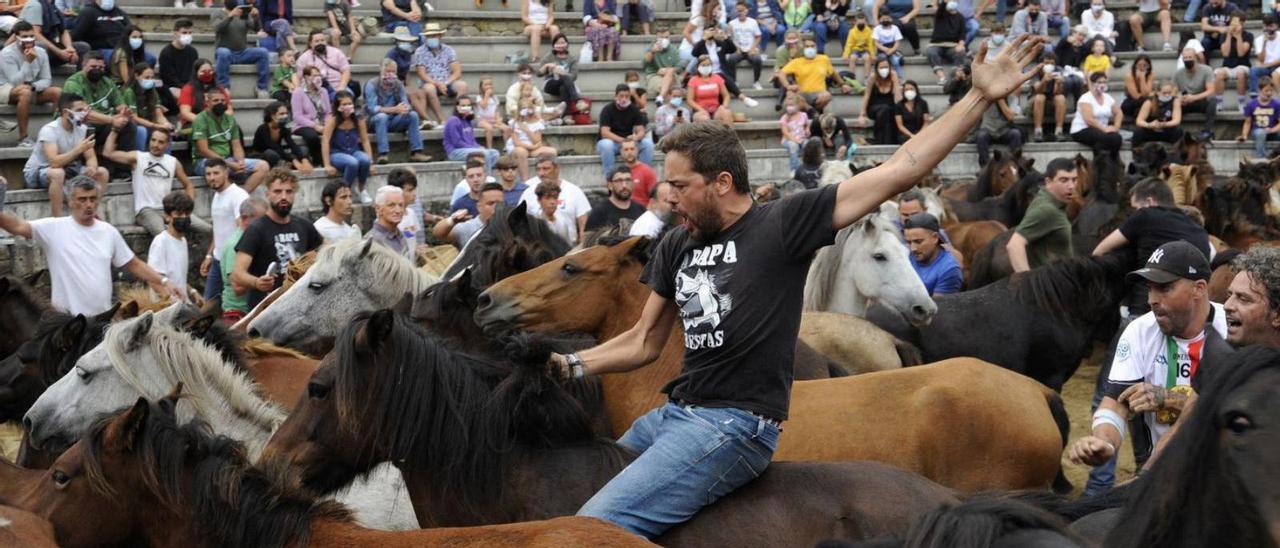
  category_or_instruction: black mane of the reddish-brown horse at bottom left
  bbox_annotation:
[84,402,353,548]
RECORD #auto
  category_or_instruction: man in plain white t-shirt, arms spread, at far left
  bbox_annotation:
[0,175,182,316]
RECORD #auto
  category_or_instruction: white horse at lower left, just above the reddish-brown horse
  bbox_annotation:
[24,312,419,530]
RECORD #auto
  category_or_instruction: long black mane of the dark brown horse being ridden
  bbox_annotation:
[333,311,609,513]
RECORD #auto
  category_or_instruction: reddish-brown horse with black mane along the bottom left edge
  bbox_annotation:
[0,398,653,548]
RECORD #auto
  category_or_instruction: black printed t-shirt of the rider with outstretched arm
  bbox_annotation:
[640,184,837,420]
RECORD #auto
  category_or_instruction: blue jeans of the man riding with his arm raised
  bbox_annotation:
[577,403,778,539]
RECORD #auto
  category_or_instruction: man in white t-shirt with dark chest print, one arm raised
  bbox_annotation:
[102,128,214,236]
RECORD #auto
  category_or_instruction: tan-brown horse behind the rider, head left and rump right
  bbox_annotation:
[476,238,1065,490]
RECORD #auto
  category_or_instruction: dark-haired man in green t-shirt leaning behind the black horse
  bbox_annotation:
[1005,157,1076,273]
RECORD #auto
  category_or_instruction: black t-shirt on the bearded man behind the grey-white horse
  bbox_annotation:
[236,215,324,309]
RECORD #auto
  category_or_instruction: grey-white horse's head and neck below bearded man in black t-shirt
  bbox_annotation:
[248,239,439,347]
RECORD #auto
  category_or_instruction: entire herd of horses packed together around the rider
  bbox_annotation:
[0,141,1280,547]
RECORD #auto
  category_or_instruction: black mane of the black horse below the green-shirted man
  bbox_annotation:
[1009,250,1132,325]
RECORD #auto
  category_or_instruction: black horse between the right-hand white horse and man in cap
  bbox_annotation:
[868,251,1130,391]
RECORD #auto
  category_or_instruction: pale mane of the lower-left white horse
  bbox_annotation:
[102,314,284,430]
